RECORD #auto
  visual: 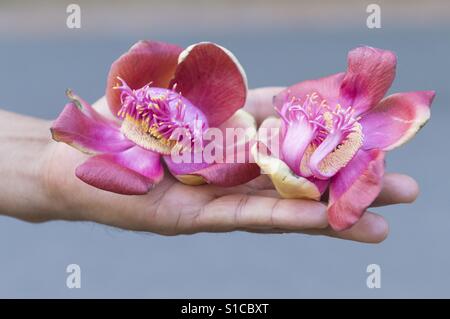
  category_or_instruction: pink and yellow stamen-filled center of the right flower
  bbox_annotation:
[279,92,363,179]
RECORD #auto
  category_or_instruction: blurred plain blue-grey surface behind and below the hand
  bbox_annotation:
[0,28,450,298]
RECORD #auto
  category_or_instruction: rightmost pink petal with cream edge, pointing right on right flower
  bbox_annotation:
[360,91,435,151]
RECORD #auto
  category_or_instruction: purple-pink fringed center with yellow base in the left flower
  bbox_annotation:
[115,78,208,155]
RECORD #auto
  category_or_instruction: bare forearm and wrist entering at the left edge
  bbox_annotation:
[0,110,51,221]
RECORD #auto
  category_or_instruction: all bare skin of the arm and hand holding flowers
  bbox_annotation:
[0,88,419,243]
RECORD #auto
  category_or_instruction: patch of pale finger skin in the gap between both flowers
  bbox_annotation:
[244,87,284,125]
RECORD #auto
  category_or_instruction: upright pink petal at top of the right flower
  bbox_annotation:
[341,46,397,114]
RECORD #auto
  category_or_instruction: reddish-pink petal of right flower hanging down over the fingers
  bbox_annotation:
[328,150,384,231]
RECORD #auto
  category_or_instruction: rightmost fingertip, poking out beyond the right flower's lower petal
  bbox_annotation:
[372,173,419,207]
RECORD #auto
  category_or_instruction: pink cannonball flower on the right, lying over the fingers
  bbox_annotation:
[252,46,435,230]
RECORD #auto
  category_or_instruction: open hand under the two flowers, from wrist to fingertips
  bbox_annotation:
[47,88,418,242]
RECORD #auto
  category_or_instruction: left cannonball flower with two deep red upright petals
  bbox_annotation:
[51,41,260,195]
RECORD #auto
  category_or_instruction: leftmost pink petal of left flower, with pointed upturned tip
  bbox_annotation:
[50,102,134,153]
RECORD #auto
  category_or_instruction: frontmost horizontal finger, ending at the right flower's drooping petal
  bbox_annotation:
[194,194,328,232]
